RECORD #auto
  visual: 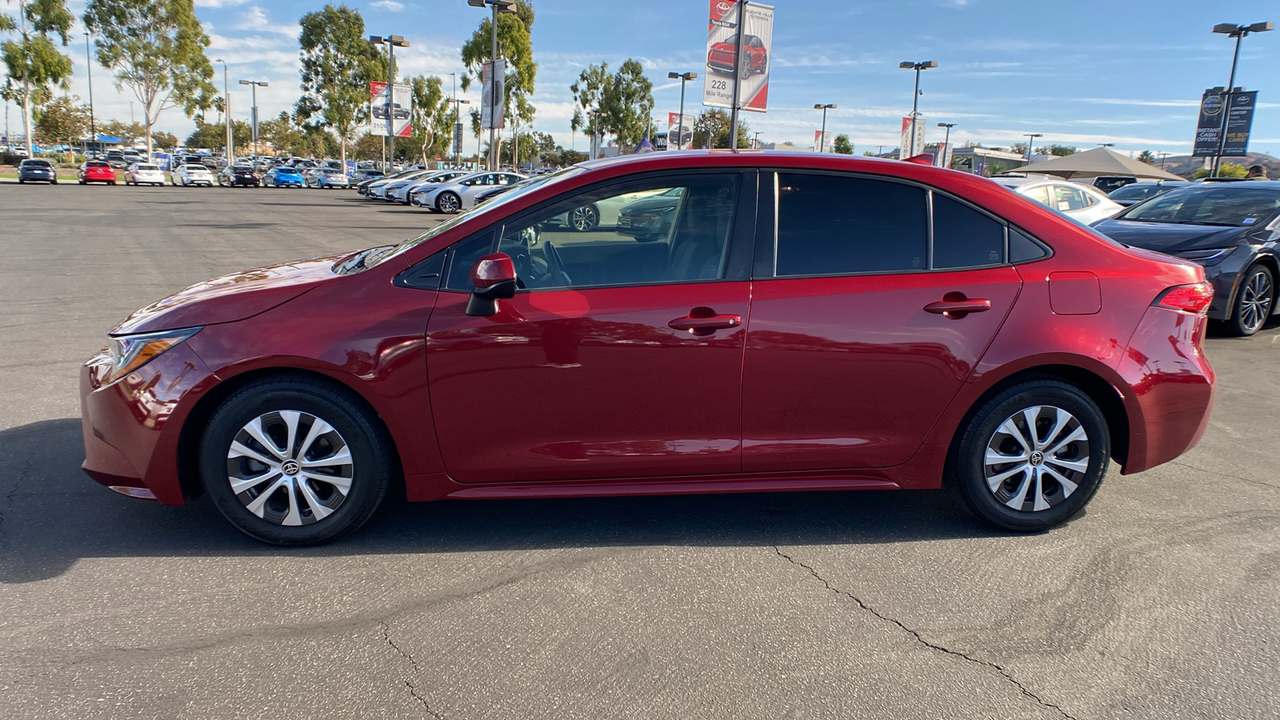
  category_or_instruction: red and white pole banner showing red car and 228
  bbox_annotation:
[703,0,773,113]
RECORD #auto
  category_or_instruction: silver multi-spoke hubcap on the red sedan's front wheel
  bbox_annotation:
[227,410,355,527]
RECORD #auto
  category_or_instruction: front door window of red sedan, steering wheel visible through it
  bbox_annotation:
[498,174,739,288]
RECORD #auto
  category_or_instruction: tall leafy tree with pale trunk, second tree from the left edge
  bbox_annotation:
[84,0,218,156]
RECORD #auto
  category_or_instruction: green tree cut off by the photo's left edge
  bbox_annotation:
[0,0,76,155]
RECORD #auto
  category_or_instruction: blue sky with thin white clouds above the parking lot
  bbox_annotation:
[10,0,1280,155]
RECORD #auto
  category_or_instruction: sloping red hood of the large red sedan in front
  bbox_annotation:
[109,252,351,336]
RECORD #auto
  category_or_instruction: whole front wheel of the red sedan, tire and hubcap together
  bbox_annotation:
[200,378,394,546]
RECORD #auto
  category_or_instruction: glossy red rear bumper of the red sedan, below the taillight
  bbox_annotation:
[1116,307,1215,475]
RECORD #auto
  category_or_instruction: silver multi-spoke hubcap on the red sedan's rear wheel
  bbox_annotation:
[983,405,1089,512]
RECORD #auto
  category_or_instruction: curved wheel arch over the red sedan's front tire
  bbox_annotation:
[178,366,404,500]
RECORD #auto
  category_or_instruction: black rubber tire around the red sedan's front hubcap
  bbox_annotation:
[200,378,396,546]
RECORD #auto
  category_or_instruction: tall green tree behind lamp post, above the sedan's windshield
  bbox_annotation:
[462,0,538,156]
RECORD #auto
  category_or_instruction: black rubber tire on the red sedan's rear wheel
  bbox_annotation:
[947,379,1111,533]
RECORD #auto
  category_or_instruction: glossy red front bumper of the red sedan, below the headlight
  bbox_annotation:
[81,343,216,505]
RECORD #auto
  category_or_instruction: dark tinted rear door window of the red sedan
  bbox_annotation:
[777,173,928,277]
